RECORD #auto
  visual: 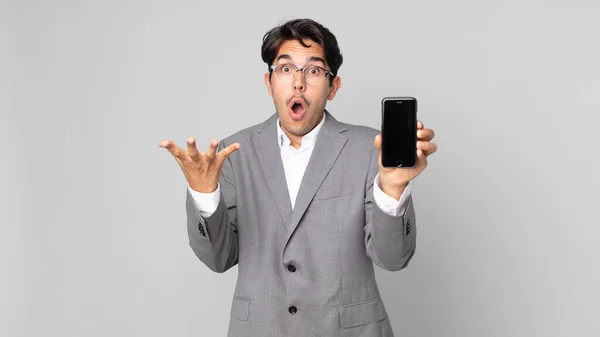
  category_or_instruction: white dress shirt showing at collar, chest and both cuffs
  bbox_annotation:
[188,114,410,218]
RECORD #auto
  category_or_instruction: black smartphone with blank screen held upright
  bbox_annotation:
[381,97,417,167]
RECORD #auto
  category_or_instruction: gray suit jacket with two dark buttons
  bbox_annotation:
[186,112,416,337]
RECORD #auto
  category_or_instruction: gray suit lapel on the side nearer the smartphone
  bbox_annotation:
[280,111,348,245]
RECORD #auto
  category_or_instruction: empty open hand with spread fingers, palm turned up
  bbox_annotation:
[158,137,240,193]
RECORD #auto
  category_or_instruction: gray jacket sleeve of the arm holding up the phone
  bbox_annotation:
[364,147,417,271]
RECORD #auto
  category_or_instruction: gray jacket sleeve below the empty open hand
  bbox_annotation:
[186,142,239,273]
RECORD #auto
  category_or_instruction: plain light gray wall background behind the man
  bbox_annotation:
[0,0,600,337]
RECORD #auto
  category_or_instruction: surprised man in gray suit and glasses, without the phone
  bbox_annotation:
[159,19,437,337]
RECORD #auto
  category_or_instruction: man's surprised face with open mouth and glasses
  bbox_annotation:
[265,40,341,142]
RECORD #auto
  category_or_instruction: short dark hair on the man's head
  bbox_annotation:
[261,19,343,84]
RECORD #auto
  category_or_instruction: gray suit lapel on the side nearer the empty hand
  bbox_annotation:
[253,114,292,230]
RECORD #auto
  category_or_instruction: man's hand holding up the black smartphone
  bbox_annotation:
[374,121,437,200]
